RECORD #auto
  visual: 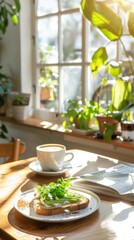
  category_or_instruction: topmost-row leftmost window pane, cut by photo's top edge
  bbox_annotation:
[37,0,58,16]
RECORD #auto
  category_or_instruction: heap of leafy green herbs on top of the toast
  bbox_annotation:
[35,178,81,206]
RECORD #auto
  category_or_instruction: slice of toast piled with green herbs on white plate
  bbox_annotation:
[34,178,89,216]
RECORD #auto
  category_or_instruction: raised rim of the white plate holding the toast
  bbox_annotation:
[13,187,100,223]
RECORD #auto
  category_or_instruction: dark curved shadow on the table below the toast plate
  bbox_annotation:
[8,208,99,240]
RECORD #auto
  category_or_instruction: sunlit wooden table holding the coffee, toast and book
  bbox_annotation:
[0,150,134,240]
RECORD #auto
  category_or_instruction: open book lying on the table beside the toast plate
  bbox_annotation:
[73,163,134,202]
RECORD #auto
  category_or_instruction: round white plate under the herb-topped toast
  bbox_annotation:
[14,188,100,222]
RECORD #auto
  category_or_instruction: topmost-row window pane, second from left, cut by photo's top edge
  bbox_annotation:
[60,0,80,10]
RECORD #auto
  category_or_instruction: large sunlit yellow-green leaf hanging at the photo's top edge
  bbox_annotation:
[80,0,123,41]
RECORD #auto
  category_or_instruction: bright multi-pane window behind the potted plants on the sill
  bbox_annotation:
[33,0,133,118]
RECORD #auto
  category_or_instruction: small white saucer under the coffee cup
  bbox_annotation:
[29,160,67,176]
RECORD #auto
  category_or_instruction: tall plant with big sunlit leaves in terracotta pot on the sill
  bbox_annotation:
[90,51,133,141]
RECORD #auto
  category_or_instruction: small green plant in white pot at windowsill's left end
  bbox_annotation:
[12,93,30,120]
